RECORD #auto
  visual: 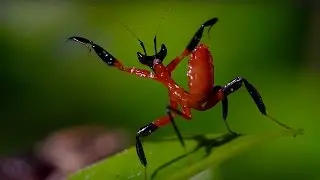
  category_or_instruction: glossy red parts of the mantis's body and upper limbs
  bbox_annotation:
[115,44,223,127]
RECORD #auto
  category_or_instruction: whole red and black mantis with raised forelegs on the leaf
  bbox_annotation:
[68,17,291,166]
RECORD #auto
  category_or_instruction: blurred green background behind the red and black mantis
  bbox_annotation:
[0,1,320,180]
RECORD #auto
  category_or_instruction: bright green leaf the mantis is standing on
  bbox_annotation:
[69,130,303,180]
